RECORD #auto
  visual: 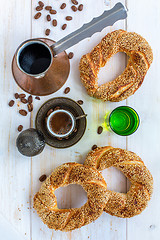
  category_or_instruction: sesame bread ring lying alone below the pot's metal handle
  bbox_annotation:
[79,30,153,102]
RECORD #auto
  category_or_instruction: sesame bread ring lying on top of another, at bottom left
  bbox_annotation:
[34,163,109,231]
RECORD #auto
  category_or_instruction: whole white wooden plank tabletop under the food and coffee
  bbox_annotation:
[0,0,160,240]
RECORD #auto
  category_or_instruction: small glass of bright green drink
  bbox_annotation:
[109,106,140,136]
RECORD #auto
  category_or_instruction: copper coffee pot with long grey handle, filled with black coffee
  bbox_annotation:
[12,3,127,96]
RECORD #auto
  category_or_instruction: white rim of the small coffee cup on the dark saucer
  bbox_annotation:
[47,109,76,138]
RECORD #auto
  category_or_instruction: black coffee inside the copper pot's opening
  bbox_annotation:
[19,43,51,75]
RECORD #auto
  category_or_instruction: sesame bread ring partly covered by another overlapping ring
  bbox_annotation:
[84,147,153,218]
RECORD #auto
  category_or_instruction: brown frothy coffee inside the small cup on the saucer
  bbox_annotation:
[49,112,72,135]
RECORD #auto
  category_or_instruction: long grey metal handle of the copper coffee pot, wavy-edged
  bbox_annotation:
[51,2,127,55]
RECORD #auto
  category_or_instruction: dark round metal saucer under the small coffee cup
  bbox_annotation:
[35,97,87,148]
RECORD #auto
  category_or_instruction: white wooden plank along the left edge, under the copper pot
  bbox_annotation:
[0,0,31,239]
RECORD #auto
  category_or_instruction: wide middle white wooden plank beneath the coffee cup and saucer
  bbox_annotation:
[31,0,126,240]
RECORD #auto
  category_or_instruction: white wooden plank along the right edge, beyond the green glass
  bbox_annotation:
[127,0,160,240]
